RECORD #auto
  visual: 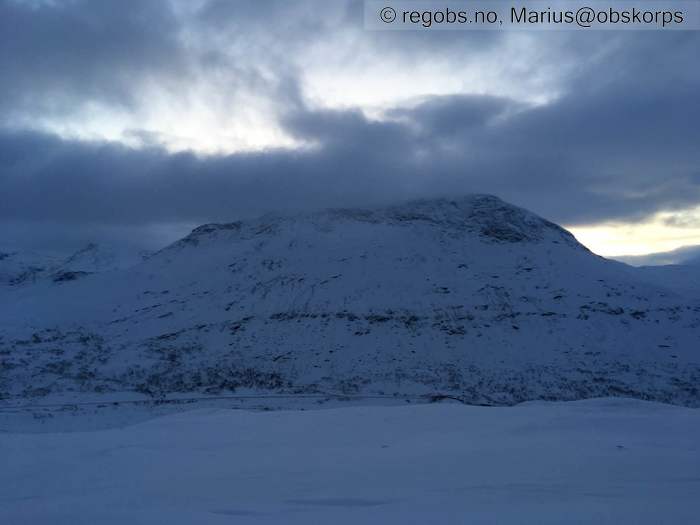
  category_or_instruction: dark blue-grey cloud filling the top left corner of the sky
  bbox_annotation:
[0,0,184,119]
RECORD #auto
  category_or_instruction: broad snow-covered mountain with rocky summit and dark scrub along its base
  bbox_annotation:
[0,195,700,406]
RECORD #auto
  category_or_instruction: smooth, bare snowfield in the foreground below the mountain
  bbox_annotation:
[0,399,700,525]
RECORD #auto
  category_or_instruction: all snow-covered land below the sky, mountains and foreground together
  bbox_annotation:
[0,195,700,525]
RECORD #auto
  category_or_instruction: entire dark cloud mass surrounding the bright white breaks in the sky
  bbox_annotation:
[0,0,700,252]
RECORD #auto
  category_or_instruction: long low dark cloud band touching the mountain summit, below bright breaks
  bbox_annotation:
[0,50,700,237]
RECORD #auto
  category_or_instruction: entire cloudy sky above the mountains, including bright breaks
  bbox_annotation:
[0,0,700,255]
